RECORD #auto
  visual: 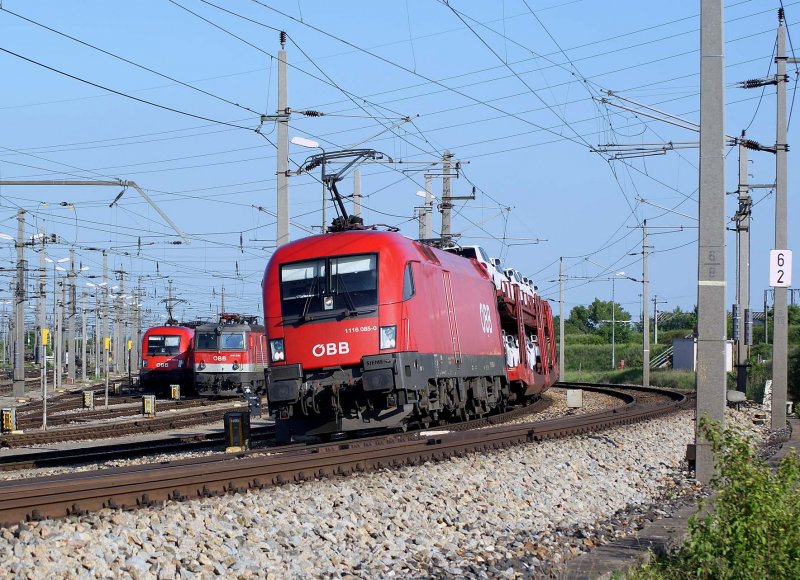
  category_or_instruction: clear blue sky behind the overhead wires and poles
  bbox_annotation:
[0,0,800,326]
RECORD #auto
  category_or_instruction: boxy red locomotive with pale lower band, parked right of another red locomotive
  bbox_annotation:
[194,314,267,395]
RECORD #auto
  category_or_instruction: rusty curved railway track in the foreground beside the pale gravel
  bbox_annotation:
[0,383,686,525]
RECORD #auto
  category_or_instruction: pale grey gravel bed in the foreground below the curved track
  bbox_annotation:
[0,394,765,578]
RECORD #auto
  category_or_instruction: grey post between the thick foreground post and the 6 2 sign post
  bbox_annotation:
[733,137,753,393]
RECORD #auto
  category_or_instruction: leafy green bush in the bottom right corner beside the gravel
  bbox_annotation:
[630,419,800,579]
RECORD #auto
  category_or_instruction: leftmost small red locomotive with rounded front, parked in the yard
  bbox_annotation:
[139,325,194,393]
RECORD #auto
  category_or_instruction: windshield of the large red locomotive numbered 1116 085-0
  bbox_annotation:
[281,254,378,321]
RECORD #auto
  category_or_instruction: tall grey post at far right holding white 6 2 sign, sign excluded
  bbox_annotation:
[771,10,789,430]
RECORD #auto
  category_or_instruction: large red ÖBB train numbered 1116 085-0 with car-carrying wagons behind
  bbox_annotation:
[262,230,557,440]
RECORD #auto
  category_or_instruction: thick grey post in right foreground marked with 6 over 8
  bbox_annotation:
[695,0,727,483]
